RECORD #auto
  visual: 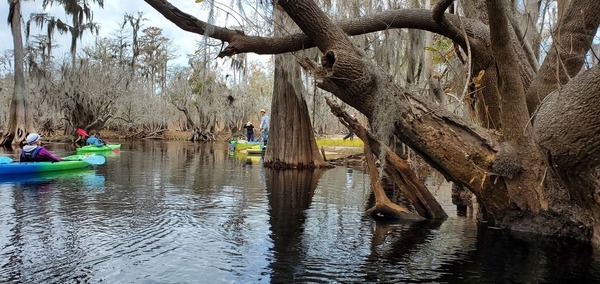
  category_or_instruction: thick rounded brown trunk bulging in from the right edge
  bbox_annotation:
[534,65,600,196]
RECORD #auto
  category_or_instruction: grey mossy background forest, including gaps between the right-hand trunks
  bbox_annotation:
[5,0,600,141]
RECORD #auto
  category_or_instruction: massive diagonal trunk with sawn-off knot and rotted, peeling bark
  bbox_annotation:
[279,1,586,237]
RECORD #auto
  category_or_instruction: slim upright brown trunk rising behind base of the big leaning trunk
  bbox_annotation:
[486,0,548,220]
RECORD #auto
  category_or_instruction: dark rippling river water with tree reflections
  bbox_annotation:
[0,141,600,283]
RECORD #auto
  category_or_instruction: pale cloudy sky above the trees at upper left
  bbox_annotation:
[0,0,232,65]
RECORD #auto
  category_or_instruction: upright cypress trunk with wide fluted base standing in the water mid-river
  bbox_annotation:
[264,5,328,168]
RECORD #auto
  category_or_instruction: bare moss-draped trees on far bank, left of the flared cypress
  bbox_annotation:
[5,0,273,135]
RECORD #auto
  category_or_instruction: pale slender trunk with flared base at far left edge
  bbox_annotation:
[0,0,35,146]
